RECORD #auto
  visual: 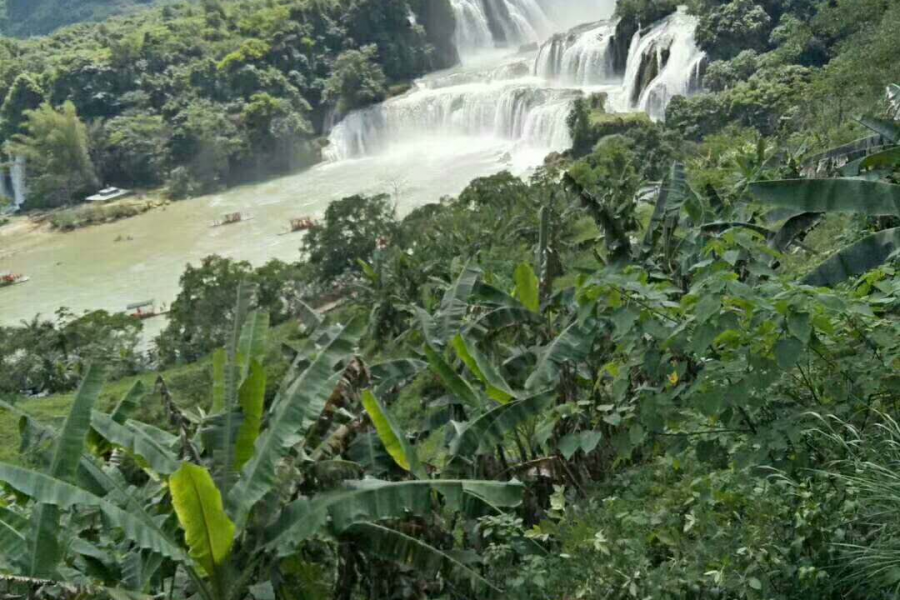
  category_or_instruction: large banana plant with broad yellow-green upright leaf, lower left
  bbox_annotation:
[0,292,522,600]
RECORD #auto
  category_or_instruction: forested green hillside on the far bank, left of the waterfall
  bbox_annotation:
[0,0,457,208]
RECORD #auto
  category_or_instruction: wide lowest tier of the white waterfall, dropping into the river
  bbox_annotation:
[328,78,579,160]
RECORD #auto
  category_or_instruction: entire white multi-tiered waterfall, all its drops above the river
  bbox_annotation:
[326,0,705,166]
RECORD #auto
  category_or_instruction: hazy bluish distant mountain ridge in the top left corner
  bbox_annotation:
[0,0,169,37]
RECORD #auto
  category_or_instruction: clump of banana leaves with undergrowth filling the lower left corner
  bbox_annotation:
[0,286,523,600]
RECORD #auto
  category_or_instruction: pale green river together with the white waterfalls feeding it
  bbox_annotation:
[0,0,703,335]
